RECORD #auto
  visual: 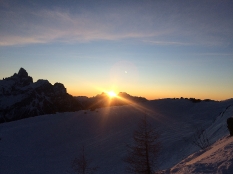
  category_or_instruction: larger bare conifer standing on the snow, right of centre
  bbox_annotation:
[124,116,160,174]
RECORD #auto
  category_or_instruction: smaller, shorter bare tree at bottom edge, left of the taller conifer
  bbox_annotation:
[72,146,98,174]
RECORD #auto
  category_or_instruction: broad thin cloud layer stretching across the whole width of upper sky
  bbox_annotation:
[0,1,232,46]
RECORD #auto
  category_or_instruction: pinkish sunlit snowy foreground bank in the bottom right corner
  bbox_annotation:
[160,136,233,174]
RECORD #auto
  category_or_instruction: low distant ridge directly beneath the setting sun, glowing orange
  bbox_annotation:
[76,92,147,110]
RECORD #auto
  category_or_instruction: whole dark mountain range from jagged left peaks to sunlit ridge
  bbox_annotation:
[0,68,147,123]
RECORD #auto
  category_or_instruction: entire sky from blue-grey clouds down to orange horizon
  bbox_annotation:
[0,0,233,100]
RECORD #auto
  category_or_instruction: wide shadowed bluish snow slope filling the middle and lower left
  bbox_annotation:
[0,99,233,174]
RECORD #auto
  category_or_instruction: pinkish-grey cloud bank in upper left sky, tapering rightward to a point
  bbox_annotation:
[0,10,171,46]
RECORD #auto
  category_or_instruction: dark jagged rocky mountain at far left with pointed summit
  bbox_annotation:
[0,68,82,123]
